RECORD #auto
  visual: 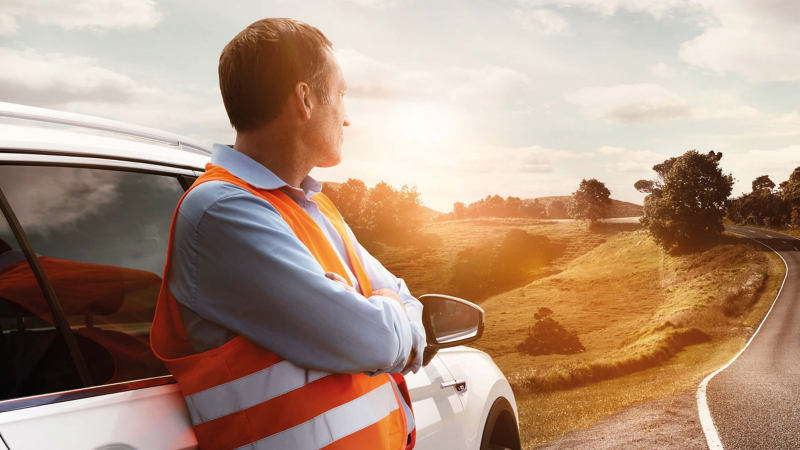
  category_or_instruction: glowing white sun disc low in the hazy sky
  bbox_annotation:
[394,104,456,145]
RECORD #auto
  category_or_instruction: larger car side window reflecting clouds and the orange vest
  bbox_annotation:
[0,166,184,385]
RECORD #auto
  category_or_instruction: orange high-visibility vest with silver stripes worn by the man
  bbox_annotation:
[150,164,416,450]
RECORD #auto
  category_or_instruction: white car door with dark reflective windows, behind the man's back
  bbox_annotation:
[0,163,197,450]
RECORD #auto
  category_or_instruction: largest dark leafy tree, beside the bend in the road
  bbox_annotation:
[640,150,733,250]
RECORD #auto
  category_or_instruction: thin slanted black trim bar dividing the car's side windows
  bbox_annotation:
[0,188,94,387]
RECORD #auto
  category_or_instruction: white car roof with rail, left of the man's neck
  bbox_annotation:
[0,102,211,170]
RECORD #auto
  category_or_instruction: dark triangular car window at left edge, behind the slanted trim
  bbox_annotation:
[0,206,83,400]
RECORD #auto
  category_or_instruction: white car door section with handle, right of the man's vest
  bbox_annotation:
[405,356,467,450]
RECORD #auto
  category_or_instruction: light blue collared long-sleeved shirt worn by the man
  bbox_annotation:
[169,144,425,429]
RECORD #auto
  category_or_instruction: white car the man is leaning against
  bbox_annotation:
[0,103,520,450]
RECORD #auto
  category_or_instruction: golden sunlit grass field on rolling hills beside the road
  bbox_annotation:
[366,219,784,448]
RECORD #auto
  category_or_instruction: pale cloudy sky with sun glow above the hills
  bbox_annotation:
[0,0,800,212]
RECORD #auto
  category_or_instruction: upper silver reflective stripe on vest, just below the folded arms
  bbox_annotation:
[184,361,330,425]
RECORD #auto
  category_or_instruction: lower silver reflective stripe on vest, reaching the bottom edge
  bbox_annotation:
[236,383,400,450]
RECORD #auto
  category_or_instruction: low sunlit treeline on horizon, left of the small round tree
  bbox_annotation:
[434,195,567,221]
